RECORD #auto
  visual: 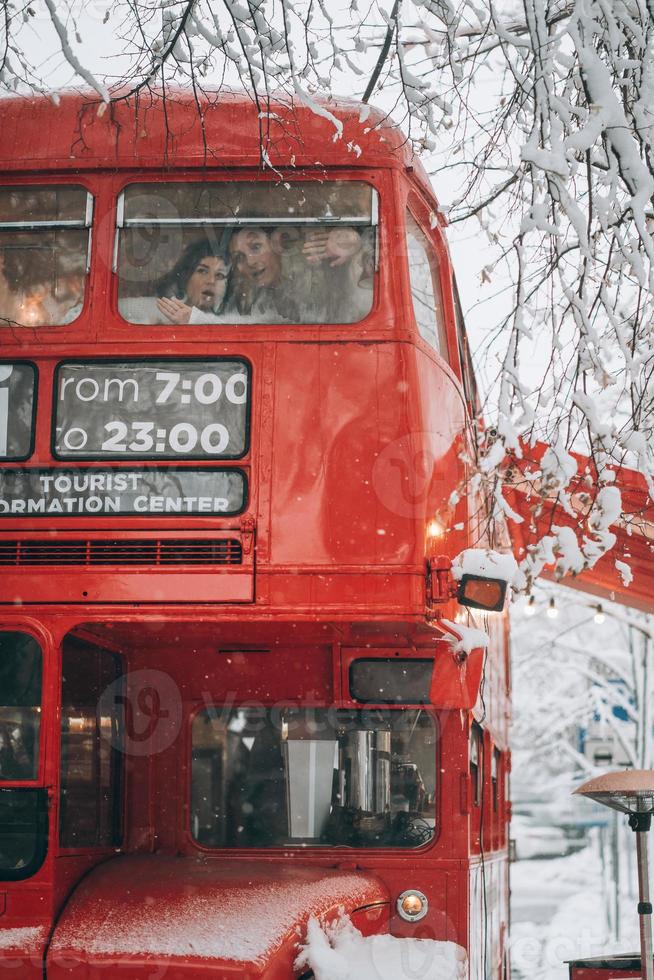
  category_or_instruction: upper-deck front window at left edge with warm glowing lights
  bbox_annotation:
[0,185,93,327]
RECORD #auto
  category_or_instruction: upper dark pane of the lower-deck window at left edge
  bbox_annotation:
[0,632,42,780]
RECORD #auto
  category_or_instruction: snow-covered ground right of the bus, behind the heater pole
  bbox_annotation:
[511,833,638,980]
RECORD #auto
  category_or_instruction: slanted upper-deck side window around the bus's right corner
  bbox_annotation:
[406,211,447,360]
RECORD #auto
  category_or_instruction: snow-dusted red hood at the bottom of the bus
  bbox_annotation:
[47,855,389,980]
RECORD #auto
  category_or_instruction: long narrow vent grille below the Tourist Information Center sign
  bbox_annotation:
[0,538,243,567]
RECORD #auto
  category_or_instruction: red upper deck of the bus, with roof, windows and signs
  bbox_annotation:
[0,90,481,622]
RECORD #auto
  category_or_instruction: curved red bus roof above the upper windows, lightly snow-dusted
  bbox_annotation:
[0,90,436,195]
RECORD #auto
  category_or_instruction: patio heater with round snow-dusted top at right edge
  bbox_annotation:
[575,769,654,980]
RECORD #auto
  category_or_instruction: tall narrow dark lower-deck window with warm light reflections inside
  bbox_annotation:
[59,639,124,848]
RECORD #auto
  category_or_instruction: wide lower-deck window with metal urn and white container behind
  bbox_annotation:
[191,707,436,847]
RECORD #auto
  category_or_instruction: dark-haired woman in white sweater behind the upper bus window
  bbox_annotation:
[119,239,230,324]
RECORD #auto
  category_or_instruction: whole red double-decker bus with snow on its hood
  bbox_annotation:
[0,95,509,980]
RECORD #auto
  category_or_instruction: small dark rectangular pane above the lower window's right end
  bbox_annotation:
[350,658,434,704]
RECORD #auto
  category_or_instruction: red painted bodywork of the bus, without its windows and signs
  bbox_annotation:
[0,90,510,980]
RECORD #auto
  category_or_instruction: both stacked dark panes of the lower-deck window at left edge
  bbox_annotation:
[0,631,47,880]
